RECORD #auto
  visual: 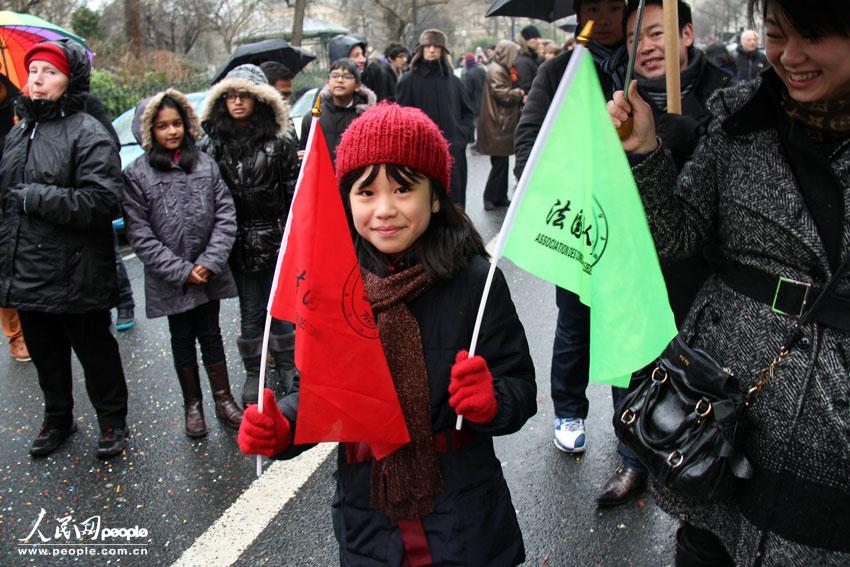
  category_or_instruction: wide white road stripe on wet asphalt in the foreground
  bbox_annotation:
[172,443,337,567]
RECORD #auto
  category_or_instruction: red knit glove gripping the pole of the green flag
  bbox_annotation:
[449,350,498,424]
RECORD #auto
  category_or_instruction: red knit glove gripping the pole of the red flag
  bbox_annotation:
[237,388,292,457]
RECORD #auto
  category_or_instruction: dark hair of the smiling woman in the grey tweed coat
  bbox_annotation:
[748,0,850,41]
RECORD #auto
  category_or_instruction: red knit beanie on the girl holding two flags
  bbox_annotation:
[336,103,452,192]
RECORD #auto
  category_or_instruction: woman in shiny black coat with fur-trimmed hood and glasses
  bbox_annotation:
[201,65,299,404]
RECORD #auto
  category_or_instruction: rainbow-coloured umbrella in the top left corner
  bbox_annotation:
[0,10,92,89]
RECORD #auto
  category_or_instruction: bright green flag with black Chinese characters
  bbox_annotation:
[502,46,676,386]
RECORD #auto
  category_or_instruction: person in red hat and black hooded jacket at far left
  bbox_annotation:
[0,40,128,458]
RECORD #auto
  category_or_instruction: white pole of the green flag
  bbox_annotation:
[455,20,593,430]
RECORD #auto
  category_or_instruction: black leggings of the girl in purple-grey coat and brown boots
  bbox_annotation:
[168,300,225,370]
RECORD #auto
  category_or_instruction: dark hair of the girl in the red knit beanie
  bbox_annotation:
[339,164,488,280]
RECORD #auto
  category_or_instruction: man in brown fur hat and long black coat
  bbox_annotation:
[396,29,474,207]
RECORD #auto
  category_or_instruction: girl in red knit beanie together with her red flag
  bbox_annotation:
[239,94,536,566]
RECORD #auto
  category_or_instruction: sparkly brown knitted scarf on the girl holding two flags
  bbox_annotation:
[363,266,443,519]
